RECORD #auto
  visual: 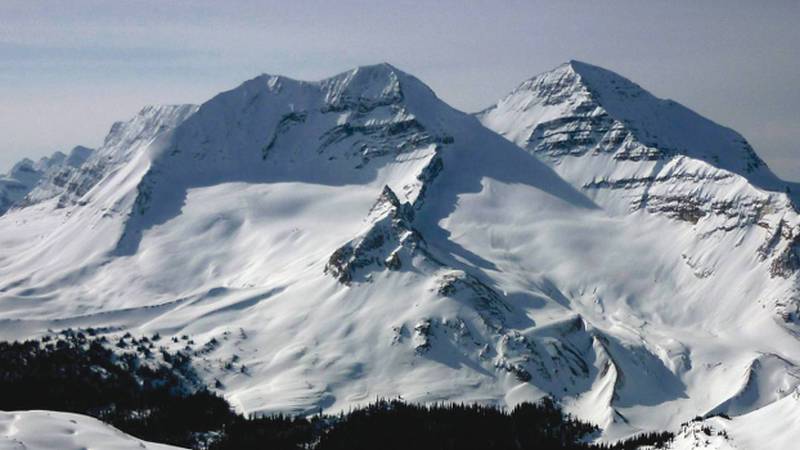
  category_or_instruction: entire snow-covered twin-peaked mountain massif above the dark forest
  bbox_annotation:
[0,63,800,448]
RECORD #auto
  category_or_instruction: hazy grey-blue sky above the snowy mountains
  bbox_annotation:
[0,0,800,181]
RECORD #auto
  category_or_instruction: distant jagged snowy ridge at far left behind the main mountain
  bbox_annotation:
[0,146,94,215]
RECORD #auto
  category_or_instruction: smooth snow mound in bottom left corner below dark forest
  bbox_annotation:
[0,411,178,450]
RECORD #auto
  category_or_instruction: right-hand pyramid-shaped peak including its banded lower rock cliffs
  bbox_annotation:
[478,61,798,277]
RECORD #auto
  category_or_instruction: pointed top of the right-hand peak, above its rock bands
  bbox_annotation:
[479,60,785,186]
